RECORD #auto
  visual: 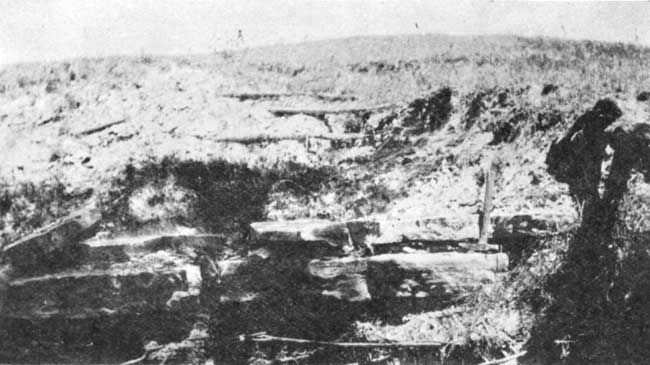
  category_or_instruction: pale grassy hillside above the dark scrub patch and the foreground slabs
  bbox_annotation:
[5,36,648,239]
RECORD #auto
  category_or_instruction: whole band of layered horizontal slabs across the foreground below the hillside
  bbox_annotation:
[0,208,573,362]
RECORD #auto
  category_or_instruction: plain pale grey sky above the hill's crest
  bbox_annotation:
[0,0,650,64]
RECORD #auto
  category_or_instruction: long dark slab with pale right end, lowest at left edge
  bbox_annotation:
[2,264,201,319]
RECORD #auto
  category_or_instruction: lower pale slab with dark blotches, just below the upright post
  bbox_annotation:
[308,252,508,301]
